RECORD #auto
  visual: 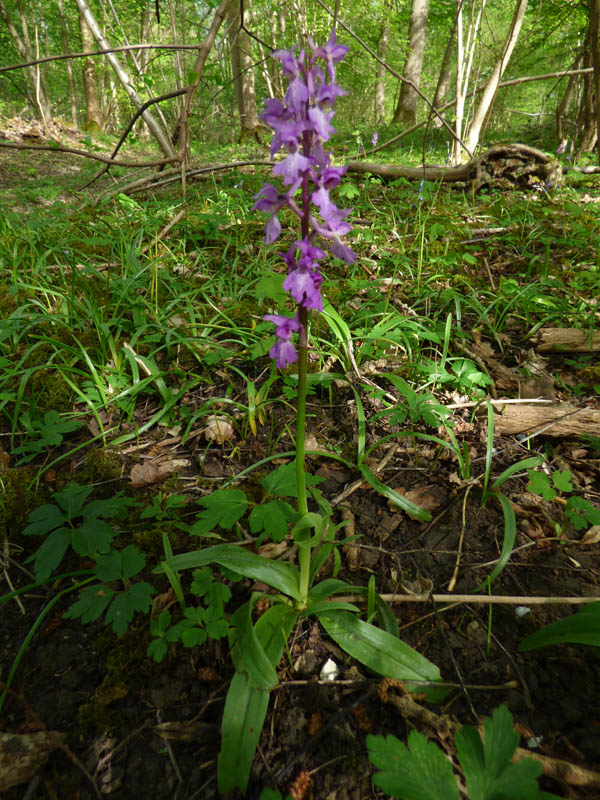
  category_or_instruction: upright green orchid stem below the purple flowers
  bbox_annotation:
[296,306,311,605]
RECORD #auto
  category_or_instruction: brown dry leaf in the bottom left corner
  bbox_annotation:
[0,731,62,792]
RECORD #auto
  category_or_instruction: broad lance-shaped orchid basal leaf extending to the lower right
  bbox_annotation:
[318,611,448,702]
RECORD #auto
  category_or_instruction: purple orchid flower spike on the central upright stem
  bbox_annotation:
[254,32,356,367]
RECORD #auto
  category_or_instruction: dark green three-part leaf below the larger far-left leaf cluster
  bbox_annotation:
[64,544,156,636]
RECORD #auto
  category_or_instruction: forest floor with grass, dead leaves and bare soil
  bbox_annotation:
[0,139,600,800]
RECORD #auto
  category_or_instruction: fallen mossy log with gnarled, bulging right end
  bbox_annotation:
[348,144,562,191]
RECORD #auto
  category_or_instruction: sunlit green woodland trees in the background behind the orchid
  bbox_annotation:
[0,0,600,163]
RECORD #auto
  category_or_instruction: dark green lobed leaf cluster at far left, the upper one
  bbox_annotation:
[23,483,135,581]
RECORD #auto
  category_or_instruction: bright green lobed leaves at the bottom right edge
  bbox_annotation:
[367,706,558,800]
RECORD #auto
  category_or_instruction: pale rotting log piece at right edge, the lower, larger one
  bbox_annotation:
[494,403,600,436]
